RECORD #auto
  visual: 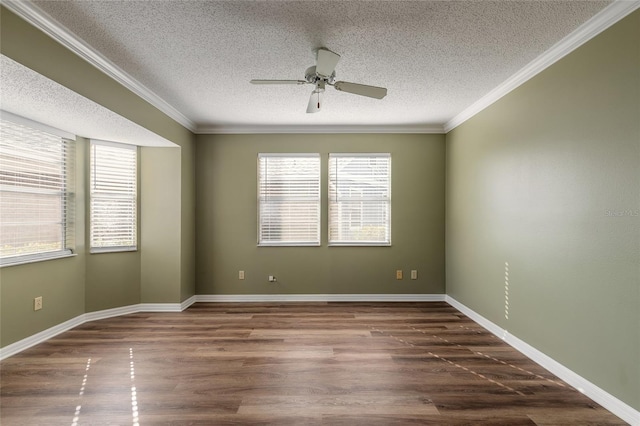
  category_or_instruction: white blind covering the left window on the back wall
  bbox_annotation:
[258,154,320,246]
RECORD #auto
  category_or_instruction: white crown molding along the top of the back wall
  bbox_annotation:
[195,124,445,135]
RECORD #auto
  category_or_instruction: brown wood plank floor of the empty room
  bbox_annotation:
[0,303,625,426]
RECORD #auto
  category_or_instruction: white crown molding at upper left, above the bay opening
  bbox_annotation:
[2,0,196,132]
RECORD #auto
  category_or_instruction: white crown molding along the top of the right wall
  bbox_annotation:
[444,0,640,133]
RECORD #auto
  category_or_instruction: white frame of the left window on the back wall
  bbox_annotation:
[256,153,322,247]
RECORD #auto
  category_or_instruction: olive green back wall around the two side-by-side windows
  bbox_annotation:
[196,134,445,294]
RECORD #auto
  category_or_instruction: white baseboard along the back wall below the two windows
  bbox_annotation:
[195,294,445,303]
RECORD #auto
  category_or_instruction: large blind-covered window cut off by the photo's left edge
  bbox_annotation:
[0,112,75,265]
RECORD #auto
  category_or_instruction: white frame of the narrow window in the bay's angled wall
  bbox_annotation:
[88,139,140,254]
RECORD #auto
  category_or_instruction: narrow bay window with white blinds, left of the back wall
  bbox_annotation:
[89,141,138,253]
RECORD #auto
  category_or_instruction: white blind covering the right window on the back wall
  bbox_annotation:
[329,153,391,245]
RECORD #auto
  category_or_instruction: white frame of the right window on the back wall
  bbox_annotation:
[327,152,393,247]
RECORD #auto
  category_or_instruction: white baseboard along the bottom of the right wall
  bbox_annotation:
[446,296,640,425]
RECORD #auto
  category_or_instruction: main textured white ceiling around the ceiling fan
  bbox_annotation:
[15,0,610,131]
